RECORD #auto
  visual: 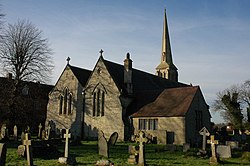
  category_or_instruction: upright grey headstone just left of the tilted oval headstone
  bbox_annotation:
[98,131,109,157]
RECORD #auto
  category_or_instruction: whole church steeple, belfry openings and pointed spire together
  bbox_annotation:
[156,9,178,82]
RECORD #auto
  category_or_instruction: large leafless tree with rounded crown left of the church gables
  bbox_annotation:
[0,20,53,82]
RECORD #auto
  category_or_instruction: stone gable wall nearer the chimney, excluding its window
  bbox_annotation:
[84,58,124,140]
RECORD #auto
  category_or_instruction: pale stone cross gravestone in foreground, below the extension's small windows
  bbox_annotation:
[135,131,148,166]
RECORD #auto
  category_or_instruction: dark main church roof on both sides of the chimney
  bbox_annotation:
[103,60,188,94]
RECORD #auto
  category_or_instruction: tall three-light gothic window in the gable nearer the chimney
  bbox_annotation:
[93,87,106,116]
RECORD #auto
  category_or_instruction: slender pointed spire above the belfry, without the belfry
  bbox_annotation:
[161,9,173,65]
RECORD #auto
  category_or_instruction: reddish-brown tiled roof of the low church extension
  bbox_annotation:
[132,86,199,117]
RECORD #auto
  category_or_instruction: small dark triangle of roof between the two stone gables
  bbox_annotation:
[68,64,92,87]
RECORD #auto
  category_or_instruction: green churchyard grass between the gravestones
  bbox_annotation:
[3,141,250,166]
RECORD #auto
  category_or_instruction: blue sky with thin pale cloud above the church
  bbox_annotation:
[0,0,250,122]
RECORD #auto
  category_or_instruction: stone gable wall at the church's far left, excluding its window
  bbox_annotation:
[46,66,83,138]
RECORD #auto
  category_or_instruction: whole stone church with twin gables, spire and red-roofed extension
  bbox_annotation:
[46,11,211,144]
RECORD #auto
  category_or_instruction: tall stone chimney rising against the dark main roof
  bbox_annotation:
[124,53,133,94]
